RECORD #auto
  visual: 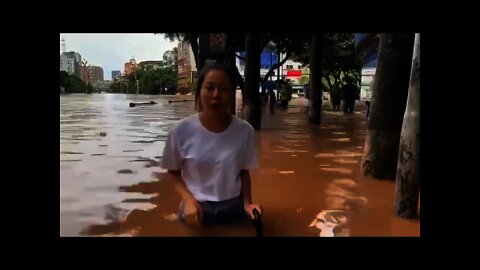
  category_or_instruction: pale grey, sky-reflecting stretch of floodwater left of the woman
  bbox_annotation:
[60,94,193,236]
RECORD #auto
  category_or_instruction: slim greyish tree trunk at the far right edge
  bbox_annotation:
[394,34,420,218]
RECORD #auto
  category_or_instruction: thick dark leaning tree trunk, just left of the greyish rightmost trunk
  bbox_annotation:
[362,33,414,179]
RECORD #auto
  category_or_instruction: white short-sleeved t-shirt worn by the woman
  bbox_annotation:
[161,114,258,201]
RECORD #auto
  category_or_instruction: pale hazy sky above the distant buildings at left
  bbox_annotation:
[60,33,177,80]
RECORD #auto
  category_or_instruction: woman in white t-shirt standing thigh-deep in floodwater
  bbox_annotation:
[161,65,261,226]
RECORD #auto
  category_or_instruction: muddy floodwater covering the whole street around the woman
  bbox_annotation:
[60,94,420,237]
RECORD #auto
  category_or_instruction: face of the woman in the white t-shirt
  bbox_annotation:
[200,70,233,112]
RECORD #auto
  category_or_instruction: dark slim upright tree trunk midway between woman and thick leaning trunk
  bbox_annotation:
[308,33,324,125]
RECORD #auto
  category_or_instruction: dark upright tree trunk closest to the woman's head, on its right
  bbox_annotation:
[242,33,262,130]
